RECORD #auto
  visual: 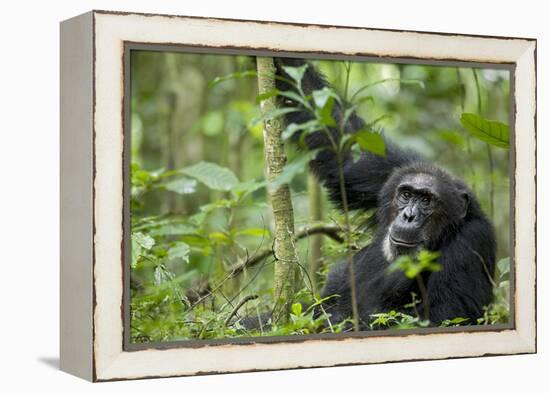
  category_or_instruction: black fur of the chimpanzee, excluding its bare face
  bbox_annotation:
[275,58,496,328]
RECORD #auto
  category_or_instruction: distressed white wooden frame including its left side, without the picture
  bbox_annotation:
[60,11,536,381]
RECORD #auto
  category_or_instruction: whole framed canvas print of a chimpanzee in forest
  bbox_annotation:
[60,11,536,381]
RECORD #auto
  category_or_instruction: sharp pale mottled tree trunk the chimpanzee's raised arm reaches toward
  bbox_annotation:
[257,57,298,323]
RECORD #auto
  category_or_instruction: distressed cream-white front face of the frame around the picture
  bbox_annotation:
[89,12,536,380]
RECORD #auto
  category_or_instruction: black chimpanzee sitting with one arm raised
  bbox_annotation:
[244,58,496,329]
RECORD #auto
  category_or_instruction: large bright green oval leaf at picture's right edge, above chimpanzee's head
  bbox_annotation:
[460,113,510,149]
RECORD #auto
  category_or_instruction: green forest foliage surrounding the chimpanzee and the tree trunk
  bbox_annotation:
[130,51,510,342]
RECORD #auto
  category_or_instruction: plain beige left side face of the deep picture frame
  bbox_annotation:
[59,12,94,381]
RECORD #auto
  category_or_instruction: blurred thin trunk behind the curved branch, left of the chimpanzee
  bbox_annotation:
[307,174,323,294]
